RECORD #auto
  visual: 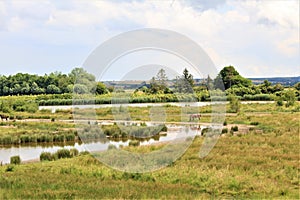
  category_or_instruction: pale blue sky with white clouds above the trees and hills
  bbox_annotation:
[0,0,300,80]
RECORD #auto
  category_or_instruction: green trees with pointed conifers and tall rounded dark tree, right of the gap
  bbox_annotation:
[136,66,300,97]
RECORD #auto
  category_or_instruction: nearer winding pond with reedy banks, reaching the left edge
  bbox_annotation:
[0,125,207,164]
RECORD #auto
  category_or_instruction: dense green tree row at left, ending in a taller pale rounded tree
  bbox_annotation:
[0,68,108,96]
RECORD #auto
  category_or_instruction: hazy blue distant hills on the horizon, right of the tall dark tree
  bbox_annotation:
[249,76,300,86]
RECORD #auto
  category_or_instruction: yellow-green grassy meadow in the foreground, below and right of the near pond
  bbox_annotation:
[0,112,300,199]
